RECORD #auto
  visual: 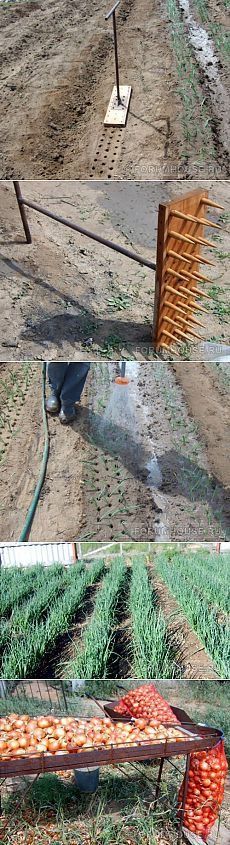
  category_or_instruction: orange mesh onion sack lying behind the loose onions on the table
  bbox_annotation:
[115,684,178,724]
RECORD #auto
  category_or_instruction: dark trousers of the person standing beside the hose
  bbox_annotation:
[47,361,90,411]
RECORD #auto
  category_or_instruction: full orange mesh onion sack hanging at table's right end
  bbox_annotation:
[178,740,228,842]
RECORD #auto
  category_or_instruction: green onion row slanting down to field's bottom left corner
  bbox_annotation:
[1,560,104,679]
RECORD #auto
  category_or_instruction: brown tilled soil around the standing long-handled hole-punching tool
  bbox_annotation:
[0,0,230,179]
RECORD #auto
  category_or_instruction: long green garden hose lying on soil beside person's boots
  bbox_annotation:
[19,363,49,543]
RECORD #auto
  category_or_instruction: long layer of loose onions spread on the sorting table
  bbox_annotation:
[0,713,187,759]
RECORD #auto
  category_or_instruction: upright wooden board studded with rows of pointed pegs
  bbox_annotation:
[153,189,225,354]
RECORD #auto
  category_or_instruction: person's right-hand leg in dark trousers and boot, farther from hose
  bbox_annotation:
[60,362,90,422]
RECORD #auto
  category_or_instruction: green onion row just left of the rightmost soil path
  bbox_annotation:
[129,556,177,678]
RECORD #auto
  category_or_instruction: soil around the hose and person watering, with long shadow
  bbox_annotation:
[0,362,230,542]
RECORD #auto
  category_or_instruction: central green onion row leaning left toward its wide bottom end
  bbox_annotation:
[64,557,127,678]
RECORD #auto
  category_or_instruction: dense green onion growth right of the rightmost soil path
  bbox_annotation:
[155,552,230,678]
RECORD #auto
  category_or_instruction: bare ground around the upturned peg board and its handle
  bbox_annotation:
[0,181,230,361]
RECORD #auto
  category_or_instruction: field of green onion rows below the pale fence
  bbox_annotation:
[0,548,230,679]
